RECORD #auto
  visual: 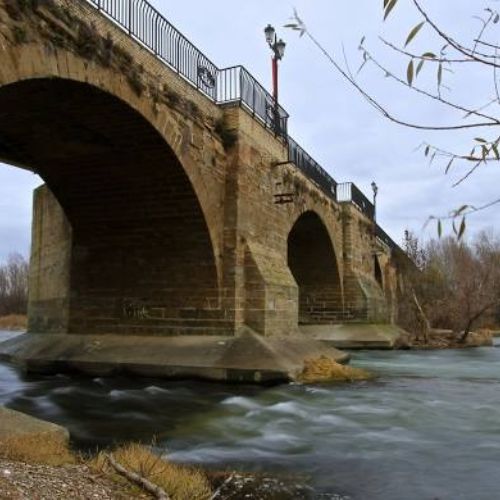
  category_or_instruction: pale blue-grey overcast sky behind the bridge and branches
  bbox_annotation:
[0,0,500,259]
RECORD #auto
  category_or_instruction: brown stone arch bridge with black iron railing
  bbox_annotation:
[0,0,408,382]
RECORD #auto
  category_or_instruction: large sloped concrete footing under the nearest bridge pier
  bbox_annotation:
[0,330,349,383]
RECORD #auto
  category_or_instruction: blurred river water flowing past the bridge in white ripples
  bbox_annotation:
[0,333,500,500]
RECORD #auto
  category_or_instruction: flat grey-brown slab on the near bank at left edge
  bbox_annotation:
[0,406,69,445]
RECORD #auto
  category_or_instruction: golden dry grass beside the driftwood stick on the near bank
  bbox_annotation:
[90,443,212,500]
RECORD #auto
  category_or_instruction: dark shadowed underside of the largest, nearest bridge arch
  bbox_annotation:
[0,78,219,334]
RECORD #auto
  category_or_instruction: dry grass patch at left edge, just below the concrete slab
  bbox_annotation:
[0,434,79,467]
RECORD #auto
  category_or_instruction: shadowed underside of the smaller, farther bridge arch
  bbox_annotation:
[288,211,344,324]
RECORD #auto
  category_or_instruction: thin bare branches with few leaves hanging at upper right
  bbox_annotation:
[285,0,500,238]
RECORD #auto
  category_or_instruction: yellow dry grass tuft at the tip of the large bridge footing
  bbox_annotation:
[297,356,375,384]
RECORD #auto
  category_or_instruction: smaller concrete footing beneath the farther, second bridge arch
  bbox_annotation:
[300,323,408,349]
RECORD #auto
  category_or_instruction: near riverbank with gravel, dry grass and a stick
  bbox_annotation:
[0,438,318,500]
